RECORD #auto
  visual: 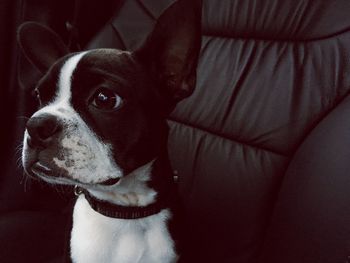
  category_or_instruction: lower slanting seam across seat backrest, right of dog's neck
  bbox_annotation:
[168,118,290,158]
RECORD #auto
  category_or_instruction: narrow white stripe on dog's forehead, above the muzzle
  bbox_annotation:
[57,51,88,101]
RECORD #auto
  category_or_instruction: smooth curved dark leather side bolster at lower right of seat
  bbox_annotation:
[261,96,350,263]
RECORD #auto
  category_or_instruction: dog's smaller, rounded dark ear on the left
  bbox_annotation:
[17,22,69,73]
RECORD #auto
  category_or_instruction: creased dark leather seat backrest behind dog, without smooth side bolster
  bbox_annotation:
[89,0,350,263]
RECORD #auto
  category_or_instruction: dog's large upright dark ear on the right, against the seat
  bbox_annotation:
[134,0,202,106]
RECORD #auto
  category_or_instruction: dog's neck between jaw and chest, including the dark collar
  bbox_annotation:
[82,157,175,219]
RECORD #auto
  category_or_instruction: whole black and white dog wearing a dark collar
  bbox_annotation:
[18,0,201,263]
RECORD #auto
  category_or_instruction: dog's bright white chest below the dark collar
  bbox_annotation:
[71,196,177,263]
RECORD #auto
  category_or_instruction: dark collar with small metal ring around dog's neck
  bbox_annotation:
[74,186,166,219]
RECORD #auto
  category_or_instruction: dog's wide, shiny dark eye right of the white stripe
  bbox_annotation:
[92,88,123,110]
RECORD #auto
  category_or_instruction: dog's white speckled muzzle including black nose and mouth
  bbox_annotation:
[23,112,121,187]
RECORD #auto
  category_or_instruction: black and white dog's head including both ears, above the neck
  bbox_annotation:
[18,0,201,190]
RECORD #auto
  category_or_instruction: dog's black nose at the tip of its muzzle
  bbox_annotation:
[27,114,61,146]
